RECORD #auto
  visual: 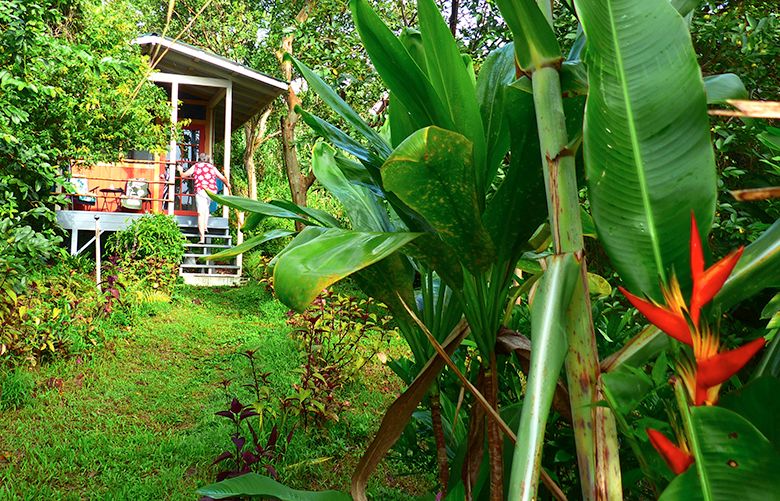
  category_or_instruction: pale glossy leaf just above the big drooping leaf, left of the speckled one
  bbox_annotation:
[311,142,391,231]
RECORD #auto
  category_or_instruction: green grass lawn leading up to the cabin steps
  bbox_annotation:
[0,284,432,500]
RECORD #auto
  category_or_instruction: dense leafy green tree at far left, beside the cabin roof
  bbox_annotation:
[0,0,167,296]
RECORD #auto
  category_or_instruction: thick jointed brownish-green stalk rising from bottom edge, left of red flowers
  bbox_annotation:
[532,57,622,500]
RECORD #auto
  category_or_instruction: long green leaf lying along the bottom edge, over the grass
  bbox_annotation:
[198,473,351,501]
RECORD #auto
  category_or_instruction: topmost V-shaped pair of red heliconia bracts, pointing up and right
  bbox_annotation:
[688,212,745,326]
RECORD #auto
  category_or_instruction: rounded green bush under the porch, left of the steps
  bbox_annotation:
[106,214,186,291]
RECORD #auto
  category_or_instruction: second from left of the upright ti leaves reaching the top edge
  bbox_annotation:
[417,0,486,195]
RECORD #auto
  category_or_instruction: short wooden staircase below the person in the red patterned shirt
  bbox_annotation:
[176,216,241,287]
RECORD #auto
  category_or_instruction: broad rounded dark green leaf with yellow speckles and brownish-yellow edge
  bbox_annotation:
[382,127,495,271]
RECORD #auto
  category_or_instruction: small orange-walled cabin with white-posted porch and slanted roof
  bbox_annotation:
[57,34,287,285]
